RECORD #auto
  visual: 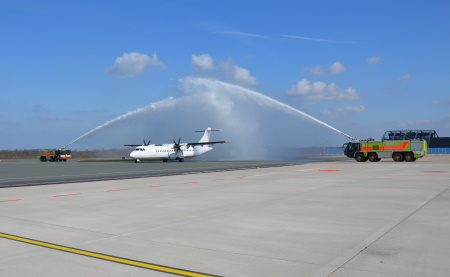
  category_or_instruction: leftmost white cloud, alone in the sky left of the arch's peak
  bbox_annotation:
[106,52,167,78]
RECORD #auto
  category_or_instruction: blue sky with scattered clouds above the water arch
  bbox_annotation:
[0,0,450,149]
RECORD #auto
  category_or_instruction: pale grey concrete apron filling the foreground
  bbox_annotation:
[0,155,450,277]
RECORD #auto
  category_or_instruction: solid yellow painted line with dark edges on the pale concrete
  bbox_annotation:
[0,233,218,277]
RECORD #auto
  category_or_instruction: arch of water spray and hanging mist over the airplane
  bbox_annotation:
[63,77,350,160]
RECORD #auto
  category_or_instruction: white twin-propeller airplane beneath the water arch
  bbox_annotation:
[124,128,229,163]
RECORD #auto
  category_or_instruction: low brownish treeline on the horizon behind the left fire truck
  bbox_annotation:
[0,149,132,160]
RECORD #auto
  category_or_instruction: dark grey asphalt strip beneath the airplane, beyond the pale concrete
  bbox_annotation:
[0,160,312,187]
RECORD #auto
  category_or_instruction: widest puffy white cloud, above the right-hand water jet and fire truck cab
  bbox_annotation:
[288,79,359,103]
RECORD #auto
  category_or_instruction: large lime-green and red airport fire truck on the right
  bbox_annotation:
[343,139,428,162]
